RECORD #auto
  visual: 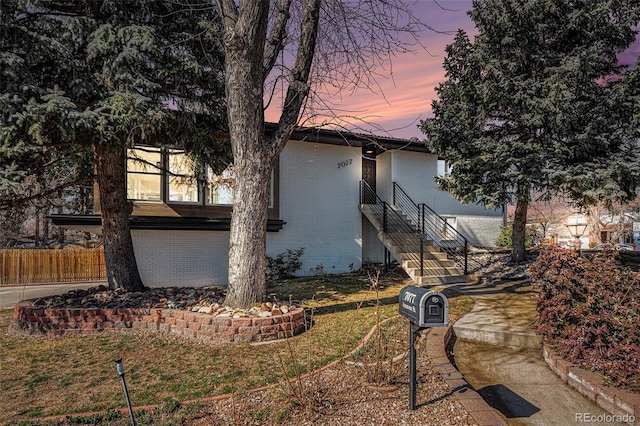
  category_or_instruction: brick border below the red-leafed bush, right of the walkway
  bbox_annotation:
[542,343,640,426]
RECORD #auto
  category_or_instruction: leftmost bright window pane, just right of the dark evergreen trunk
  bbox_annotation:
[127,148,162,201]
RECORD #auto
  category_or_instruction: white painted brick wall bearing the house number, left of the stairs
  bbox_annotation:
[267,141,362,275]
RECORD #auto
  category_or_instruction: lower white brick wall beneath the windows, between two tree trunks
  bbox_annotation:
[131,229,229,287]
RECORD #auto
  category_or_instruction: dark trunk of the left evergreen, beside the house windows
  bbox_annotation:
[95,146,144,291]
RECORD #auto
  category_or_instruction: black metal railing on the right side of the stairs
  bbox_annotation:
[393,182,469,275]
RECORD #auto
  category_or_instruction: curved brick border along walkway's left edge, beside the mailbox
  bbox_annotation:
[426,325,507,426]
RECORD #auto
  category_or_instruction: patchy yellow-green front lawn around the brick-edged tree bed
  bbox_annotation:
[0,273,473,425]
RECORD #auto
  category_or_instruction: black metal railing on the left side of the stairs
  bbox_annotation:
[360,180,425,276]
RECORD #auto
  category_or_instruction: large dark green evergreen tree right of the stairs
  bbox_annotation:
[421,0,640,262]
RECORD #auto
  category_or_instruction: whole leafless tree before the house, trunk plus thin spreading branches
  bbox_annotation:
[216,0,430,306]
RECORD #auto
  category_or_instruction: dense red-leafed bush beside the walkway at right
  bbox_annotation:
[530,247,640,388]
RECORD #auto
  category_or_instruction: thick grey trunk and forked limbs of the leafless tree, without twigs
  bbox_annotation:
[216,0,320,307]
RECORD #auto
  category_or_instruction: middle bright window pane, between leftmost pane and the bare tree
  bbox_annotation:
[168,149,200,203]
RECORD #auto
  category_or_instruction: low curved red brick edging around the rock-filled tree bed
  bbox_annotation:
[12,302,305,343]
